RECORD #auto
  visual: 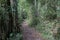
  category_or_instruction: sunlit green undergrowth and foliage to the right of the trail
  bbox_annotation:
[19,0,60,40]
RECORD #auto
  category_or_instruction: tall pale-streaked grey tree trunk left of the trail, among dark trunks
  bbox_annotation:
[10,0,19,31]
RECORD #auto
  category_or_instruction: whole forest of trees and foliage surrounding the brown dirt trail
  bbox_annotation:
[0,0,60,40]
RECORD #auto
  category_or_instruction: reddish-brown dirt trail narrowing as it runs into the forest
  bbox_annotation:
[22,21,43,40]
